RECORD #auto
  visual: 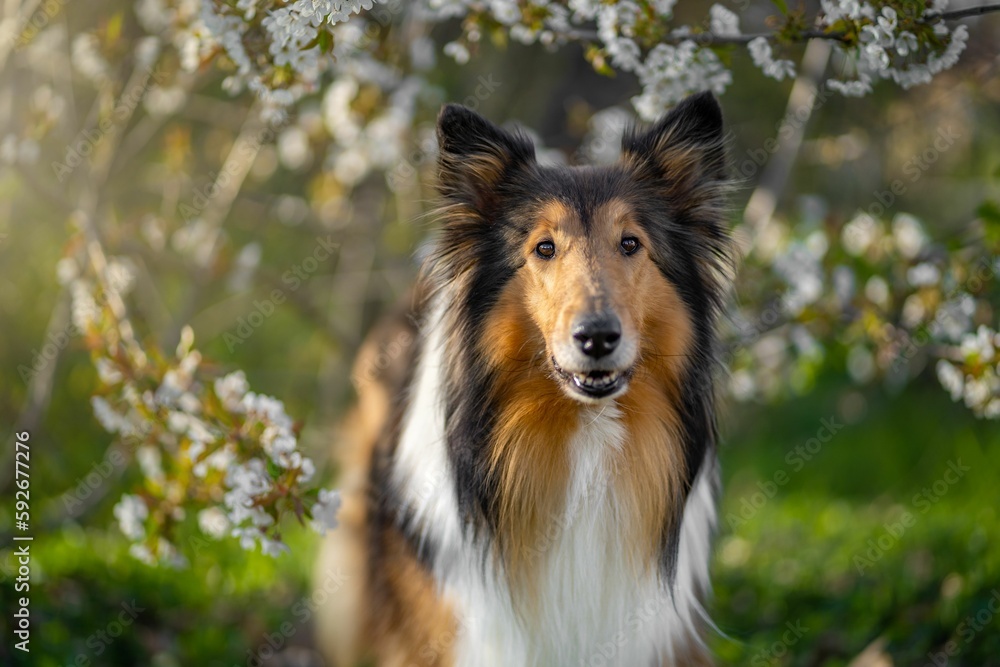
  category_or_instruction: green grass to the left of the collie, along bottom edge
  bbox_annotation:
[0,526,316,667]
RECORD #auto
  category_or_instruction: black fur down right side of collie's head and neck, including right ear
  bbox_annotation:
[622,92,735,571]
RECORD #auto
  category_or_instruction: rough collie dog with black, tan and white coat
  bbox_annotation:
[316,94,731,667]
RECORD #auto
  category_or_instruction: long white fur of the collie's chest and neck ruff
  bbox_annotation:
[391,308,717,667]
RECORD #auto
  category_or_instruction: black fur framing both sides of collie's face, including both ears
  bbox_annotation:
[423,93,732,572]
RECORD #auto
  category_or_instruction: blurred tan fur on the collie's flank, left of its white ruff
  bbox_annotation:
[314,294,456,667]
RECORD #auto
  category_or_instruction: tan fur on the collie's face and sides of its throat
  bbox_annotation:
[482,201,692,591]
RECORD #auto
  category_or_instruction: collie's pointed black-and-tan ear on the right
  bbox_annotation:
[622,91,726,215]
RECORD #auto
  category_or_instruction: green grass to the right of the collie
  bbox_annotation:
[713,380,1000,667]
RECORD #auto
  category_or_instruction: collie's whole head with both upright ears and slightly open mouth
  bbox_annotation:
[436,93,729,403]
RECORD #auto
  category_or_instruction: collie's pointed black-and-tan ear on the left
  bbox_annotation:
[437,104,535,212]
